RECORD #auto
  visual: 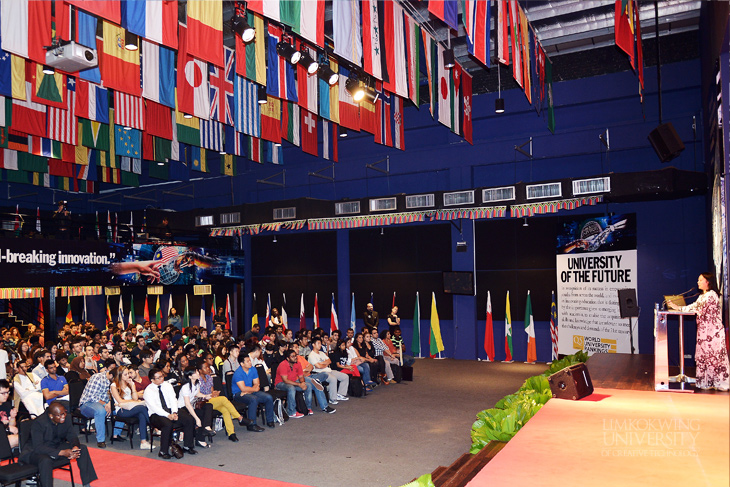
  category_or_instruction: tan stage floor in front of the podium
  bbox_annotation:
[467,389,730,487]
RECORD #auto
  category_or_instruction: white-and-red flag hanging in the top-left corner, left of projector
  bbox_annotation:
[0,0,52,64]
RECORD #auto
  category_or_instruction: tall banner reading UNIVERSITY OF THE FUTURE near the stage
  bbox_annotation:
[556,214,637,355]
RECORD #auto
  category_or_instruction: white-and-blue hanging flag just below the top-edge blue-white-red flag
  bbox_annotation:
[142,40,177,108]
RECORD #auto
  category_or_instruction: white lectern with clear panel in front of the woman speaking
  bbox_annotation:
[654,304,695,393]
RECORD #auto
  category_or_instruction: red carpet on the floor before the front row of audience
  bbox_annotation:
[53,448,310,487]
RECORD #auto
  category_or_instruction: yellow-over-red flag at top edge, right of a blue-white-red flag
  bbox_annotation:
[185,0,225,66]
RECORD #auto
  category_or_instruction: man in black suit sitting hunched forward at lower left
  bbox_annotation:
[20,401,98,487]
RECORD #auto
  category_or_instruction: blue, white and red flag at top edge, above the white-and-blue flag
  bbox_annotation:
[121,0,178,49]
